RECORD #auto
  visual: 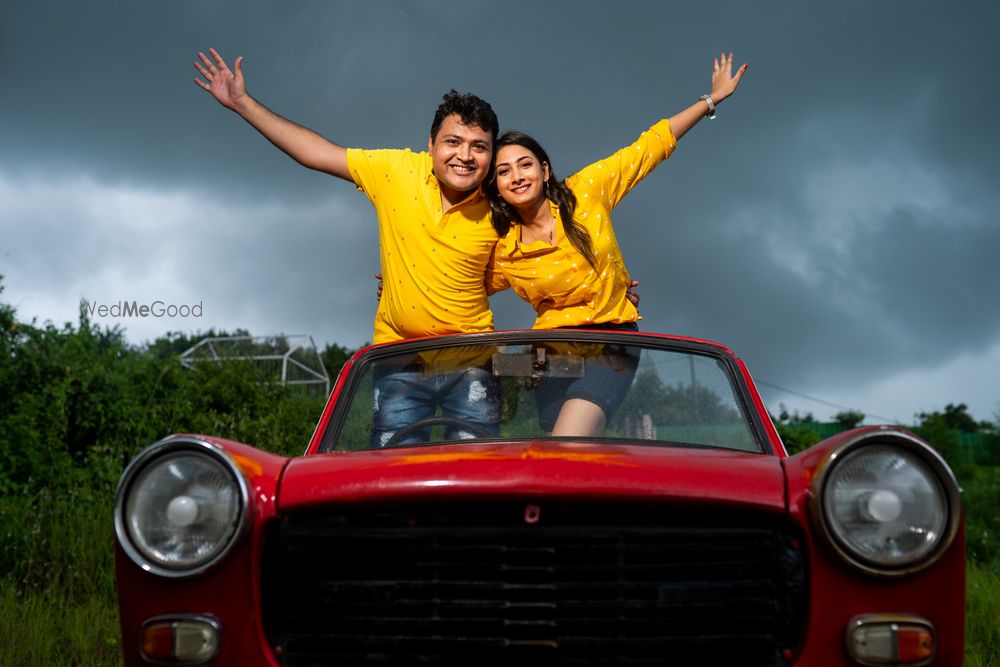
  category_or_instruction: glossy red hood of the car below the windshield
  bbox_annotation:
[278,441,785,512]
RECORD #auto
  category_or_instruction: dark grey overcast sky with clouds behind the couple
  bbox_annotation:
[0,0,1000,423]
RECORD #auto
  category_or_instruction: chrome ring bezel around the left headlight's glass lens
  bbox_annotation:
[114,437,252,578]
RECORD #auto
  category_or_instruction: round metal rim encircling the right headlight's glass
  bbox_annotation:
[809,430,962,577]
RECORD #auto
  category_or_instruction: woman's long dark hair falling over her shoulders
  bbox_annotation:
[484,131,597,270]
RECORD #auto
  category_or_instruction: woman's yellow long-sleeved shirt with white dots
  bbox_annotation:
[487,119,677,329]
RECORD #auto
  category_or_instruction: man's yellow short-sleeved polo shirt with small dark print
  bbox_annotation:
[347,148,497,343]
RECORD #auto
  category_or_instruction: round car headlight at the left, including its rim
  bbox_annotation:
[115,438,248,577]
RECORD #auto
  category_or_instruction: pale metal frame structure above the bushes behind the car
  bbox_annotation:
[181,334,330,396]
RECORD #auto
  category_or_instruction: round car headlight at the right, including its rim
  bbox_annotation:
[814,432,961,574]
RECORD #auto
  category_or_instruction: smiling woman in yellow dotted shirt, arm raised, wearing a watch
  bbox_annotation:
[486,53,747,436]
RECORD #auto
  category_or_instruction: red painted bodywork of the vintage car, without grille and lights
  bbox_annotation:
[116,339,965,667]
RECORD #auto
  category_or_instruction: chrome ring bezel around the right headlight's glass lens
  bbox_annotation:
[810,430,962,577]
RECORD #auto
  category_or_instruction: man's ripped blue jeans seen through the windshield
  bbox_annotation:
[369,367,500,449]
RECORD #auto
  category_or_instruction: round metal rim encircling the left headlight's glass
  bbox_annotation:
[114,436,253,579]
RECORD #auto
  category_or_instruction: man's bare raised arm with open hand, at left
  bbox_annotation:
[194,49,354,182]
